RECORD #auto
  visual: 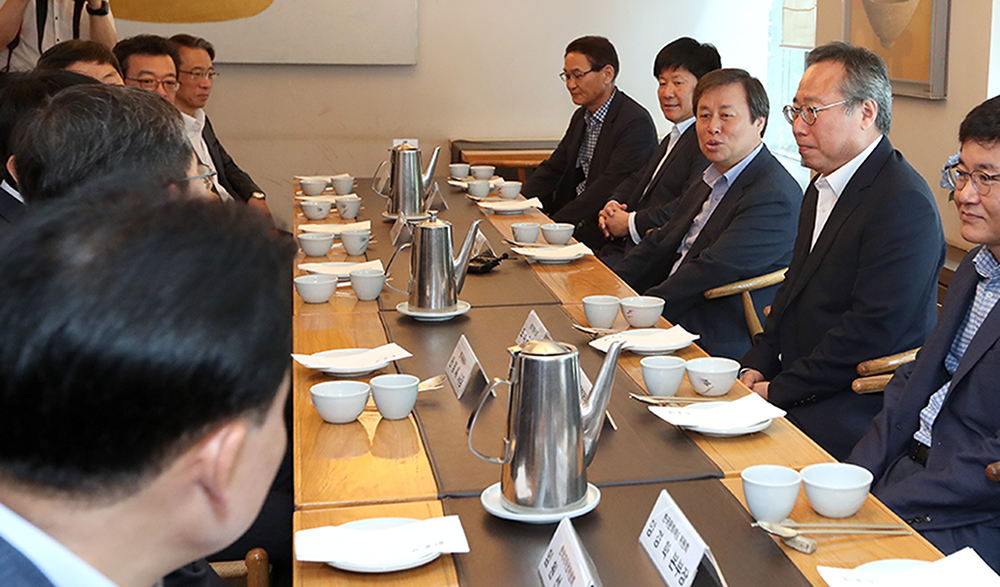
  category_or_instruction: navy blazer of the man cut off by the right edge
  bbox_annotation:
[849,249,1000,536]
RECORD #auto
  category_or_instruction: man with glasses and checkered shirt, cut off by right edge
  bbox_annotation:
[848,98,1000,570]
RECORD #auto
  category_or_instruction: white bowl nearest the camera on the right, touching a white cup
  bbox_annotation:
[802,463,874,518]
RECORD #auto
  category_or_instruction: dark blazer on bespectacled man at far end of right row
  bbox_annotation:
[521,89,656,247]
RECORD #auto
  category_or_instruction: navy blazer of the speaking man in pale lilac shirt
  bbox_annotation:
[614,146,802,358]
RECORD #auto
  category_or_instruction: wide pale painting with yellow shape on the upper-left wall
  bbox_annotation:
[112,0,417,65]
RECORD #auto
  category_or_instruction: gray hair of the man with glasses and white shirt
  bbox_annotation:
[806,41,892,135]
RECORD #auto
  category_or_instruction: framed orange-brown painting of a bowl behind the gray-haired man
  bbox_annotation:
[844,0,950,100]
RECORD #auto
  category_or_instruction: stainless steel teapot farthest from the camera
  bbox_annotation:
[372,143,441,216]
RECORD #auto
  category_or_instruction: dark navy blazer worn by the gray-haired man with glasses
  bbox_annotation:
[742,137,945,460]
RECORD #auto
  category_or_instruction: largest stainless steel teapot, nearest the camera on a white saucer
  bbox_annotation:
[466,340,624,513]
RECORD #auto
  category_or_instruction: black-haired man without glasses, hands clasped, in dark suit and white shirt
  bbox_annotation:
[597,37,722,265]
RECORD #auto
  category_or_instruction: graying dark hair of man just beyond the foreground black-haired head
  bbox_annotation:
[13,85,194,203]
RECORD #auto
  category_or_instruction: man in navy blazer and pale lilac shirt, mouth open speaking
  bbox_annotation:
[614,69,802,357]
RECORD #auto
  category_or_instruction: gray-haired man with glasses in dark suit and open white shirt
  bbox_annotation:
[742,43,945,459]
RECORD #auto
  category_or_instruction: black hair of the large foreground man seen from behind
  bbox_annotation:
[0,176,294,500]
